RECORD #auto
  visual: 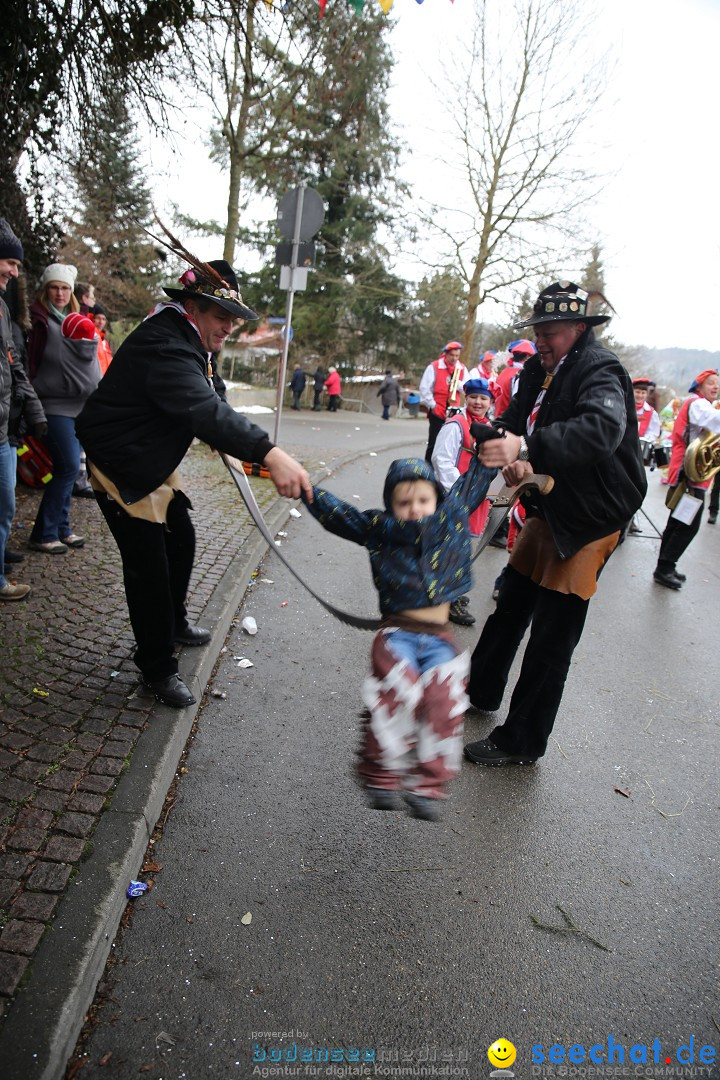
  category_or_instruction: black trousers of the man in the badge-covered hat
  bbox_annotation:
[467,566,589,757]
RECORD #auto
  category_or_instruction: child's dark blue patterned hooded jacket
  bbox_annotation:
[305,458,497,615]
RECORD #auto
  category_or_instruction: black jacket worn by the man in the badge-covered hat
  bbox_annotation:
[501,329,648,558]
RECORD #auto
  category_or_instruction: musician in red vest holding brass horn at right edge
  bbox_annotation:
[653,367,720,591]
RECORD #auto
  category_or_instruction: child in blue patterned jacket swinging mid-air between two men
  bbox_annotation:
[305,458,497,821]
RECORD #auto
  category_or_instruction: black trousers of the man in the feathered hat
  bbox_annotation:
[97,491,195,680]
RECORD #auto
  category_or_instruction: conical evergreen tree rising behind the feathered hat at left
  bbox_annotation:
[60,95,161,322]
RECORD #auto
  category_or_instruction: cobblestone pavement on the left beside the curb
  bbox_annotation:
[0,445,330,1016]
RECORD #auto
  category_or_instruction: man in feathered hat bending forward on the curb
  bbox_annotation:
[76,247,312,708]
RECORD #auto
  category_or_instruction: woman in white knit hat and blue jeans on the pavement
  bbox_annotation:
[28,262,100,555]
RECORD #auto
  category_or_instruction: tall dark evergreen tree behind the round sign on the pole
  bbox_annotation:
[208,4,409,370]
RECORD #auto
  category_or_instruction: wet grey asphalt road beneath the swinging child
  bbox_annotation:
[69,442,720,1080]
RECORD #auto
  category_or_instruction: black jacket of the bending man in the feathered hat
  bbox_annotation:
[76,308,273,504]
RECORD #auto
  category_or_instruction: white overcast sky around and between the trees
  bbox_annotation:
[148,0,720,350]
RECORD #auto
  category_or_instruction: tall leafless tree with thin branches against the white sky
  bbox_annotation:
[418,0,606,349]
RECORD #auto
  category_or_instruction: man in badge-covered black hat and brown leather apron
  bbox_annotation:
[465,281,647,766]
